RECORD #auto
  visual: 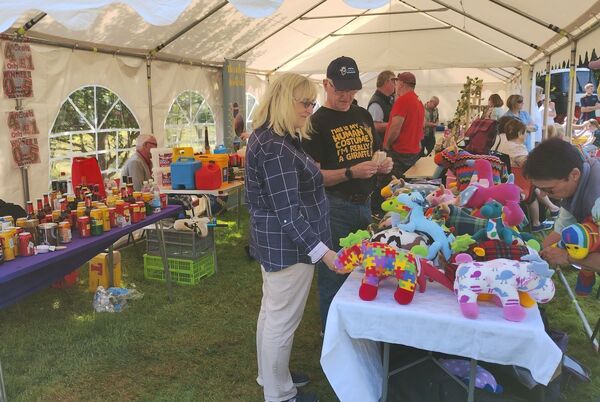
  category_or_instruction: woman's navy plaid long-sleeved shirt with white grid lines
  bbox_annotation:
[245,127,331,272]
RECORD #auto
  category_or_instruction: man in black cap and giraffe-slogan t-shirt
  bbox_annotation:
[303,57,392,330]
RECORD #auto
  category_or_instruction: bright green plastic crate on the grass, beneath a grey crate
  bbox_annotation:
[144,253,215,285]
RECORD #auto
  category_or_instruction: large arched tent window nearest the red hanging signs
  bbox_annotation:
[49,85,140,184]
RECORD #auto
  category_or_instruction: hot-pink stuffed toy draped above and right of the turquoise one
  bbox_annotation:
[460,160,525,226]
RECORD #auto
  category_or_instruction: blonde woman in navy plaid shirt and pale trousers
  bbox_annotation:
[246,73,335,402]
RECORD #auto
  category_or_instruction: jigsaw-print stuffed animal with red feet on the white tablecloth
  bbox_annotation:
[335,240,452,304]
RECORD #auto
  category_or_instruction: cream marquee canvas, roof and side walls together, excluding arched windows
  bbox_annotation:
[0,0,600,203]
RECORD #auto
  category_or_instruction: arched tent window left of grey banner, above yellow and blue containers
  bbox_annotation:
[165,91,217,150]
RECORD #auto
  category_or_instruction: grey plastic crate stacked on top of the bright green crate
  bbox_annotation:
[146,229,214,259]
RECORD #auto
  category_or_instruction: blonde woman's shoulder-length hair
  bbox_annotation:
[252,73,317,138]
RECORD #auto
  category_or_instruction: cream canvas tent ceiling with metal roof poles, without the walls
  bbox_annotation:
[0,0,600,76]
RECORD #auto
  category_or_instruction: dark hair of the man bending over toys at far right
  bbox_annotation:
[523,137,583,180]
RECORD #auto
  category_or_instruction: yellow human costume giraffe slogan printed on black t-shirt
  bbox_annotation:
[331,123,373,162]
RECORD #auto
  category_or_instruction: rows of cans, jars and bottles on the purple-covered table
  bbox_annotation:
[0,177,167,263]
